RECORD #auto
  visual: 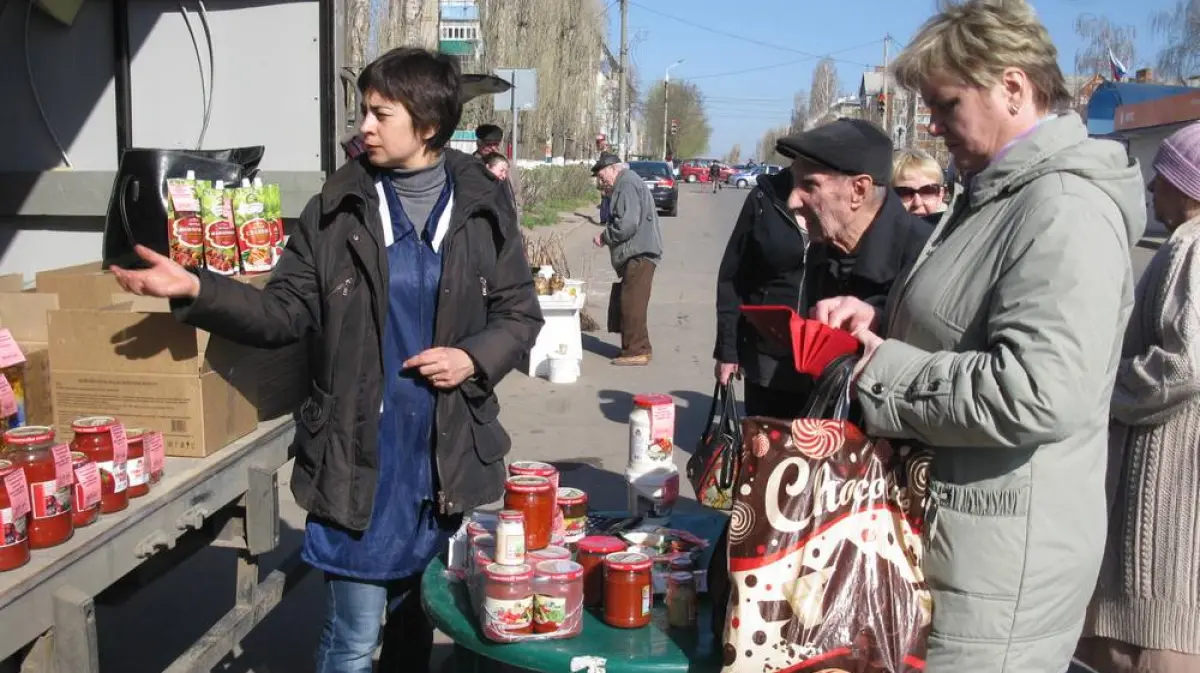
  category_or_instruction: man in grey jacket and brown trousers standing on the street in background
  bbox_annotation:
[592,152,662,367]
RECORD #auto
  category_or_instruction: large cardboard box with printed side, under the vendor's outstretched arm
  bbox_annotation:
[49,305,258,457]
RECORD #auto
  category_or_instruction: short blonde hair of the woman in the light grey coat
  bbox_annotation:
[892,0,1070,112]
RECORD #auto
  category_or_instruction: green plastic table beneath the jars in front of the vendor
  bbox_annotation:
[421,512,726,673]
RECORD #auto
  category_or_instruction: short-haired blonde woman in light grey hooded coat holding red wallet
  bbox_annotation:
[816,0,1146,673]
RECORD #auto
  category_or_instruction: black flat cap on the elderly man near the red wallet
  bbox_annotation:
[775,118,892,185]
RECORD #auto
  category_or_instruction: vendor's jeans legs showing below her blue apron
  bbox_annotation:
[317,573,433,673]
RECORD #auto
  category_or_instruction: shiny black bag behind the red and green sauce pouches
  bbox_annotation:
[102,145,265,269]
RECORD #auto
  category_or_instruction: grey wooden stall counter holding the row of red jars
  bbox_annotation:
[0,416,308,673]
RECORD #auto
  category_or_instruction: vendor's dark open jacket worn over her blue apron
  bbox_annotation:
[175,150,542,530]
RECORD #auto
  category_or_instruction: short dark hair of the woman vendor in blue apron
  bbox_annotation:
[358,47,462,150]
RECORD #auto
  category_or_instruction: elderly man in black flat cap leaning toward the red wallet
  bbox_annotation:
[775,118,934,316]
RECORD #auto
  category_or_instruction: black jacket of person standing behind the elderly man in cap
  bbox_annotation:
[713,170,809,391]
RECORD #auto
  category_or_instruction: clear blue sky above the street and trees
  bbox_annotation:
[606,0,1174,157]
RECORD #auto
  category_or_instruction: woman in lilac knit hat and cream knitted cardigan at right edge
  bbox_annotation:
[1079,122,1200,673]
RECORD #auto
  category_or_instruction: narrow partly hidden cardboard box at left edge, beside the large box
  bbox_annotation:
[0,292,59,425]
